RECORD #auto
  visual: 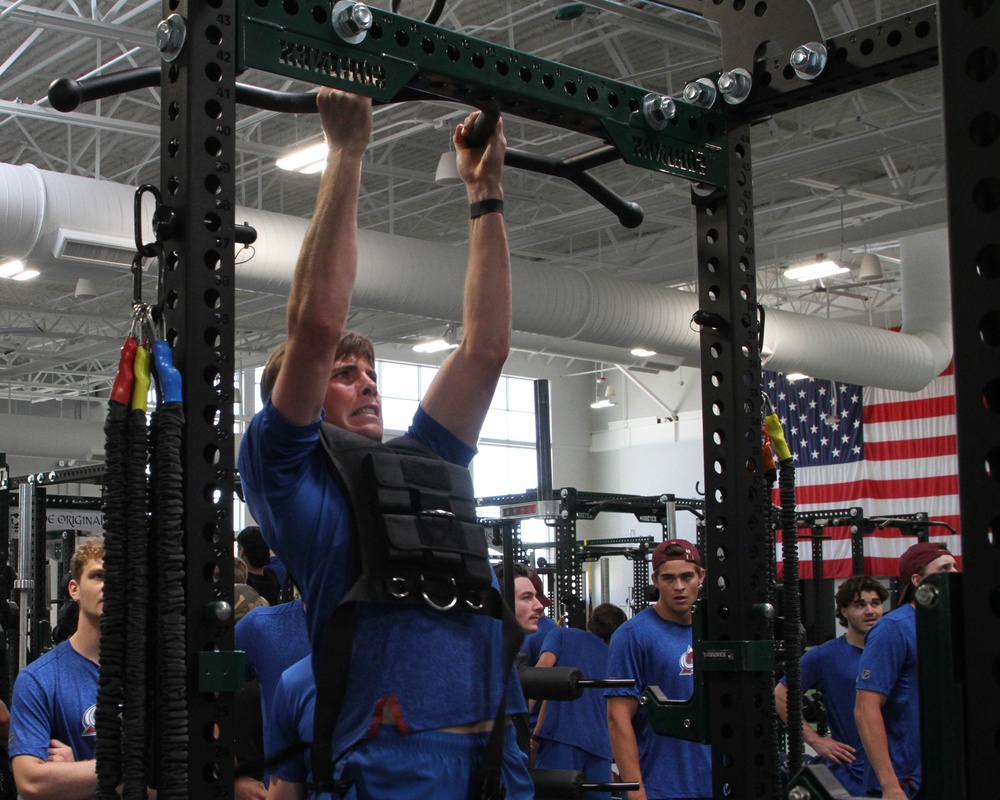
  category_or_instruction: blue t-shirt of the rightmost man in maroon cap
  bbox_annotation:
[857,603,920,795]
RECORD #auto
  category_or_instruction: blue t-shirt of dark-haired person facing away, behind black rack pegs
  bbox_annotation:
[538,627,611,761]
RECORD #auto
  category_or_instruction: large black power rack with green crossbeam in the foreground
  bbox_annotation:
[45,0,1000,800]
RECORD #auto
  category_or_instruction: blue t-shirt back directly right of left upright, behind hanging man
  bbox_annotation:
[235,600,312,719]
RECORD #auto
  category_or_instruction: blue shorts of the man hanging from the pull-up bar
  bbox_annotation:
[334,725,535,800]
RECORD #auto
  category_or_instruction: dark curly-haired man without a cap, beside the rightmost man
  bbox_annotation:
[774,575,889,796]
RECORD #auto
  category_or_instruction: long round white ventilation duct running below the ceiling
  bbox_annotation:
[0,164,951,391]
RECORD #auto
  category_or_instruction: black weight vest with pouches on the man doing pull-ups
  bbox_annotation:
[311,423,523,792]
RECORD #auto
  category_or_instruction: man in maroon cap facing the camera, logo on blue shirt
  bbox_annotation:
[604,539,712,800]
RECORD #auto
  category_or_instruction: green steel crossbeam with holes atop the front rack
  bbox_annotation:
[237,2,725,187]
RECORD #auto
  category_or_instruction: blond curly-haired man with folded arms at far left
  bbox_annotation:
[8,538,104,800]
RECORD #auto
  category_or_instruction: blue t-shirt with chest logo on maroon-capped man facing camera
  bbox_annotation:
[604,606,712,800]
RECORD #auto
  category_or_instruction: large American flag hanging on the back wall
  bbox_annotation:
[764,366,961,578]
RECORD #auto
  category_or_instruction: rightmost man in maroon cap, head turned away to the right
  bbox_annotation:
[854,542,957,800]
